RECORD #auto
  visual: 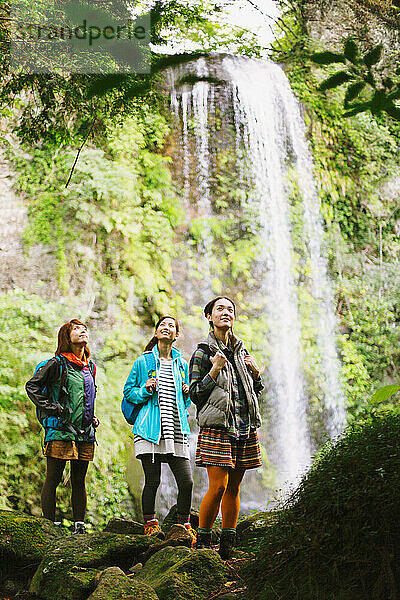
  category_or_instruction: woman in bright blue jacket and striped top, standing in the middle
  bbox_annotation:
[124,316,193,535]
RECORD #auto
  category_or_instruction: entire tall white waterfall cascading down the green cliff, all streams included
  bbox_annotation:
[169,55,344,506]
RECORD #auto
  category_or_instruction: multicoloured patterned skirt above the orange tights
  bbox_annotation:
[196,427,262,469]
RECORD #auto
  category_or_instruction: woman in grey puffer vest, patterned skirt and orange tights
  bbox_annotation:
[190,296,263,559]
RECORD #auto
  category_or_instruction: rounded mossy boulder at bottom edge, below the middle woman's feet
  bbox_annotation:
[135,547,228,600]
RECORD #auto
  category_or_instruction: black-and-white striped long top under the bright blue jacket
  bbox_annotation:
[134,360,189,458]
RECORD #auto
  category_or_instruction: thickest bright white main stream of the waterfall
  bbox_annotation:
[223,58,311,482]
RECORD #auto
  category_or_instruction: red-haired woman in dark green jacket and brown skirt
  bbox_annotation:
[26,319,99,533]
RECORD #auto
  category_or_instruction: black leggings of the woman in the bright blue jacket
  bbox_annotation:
[139,454,193,516]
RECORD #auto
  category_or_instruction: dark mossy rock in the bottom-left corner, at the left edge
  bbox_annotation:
[0,510,65,579]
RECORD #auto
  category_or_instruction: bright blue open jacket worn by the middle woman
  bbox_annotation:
[124,344,191,444]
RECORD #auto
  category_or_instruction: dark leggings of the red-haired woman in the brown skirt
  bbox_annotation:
[42,456,89,521]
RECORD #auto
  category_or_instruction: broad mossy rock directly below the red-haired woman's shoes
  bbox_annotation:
[30,532,151,600]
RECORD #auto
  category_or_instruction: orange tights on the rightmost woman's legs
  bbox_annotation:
[199,467,244,529]
